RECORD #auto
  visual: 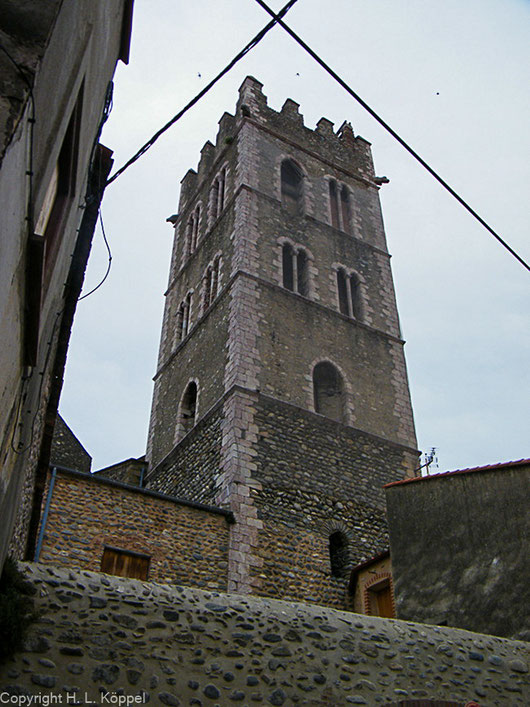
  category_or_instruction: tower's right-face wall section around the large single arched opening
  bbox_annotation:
[254,284,417,454]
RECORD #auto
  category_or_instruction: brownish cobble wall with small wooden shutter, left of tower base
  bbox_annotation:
[35,472,229,590]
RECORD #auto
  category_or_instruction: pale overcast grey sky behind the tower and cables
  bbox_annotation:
[60,0,530,470]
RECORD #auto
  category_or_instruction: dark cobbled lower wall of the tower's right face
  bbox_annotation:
[251,395,417,607]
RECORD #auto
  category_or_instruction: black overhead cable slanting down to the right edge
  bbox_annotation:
[256,0,530,271]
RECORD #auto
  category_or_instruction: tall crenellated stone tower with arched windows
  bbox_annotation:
[147,77,418,607]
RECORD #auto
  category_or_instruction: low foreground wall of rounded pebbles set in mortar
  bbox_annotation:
[0,564,530,707]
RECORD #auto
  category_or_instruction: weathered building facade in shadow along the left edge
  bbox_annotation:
[0,0,133,567]
